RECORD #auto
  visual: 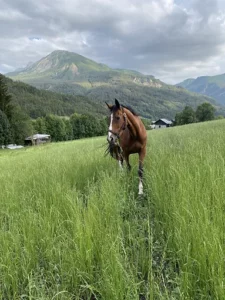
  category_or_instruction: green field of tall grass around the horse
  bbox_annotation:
[0,120,225,300]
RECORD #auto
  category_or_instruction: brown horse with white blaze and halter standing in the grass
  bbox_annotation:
[106,99,147,195]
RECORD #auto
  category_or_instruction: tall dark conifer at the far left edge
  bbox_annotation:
[0,74,14,121]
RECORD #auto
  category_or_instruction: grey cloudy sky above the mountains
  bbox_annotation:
[0,0,225,83]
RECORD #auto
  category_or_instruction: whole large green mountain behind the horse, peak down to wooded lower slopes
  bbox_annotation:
[7,50,224,119]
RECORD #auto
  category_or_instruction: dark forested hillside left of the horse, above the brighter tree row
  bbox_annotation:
[1,77,106,118]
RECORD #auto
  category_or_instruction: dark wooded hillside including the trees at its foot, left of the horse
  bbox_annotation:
[0,74,108,148]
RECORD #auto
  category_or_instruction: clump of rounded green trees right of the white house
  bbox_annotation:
[175,102,216,125]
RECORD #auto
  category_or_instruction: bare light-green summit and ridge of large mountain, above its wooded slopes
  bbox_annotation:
[6,50,163,89]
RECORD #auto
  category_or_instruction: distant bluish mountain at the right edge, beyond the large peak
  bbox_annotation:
[176,74,225,105]
